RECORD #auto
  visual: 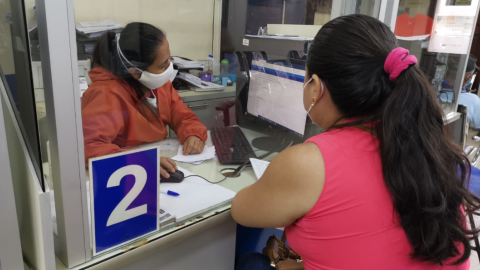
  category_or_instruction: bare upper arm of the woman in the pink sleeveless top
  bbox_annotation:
[232,140,325,228]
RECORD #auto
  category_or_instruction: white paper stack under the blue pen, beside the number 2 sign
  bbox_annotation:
[160,167,236,222]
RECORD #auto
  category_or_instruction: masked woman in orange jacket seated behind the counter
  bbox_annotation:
[82,23,207,177]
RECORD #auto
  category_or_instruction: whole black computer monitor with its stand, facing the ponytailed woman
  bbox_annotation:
[237,56,321,151]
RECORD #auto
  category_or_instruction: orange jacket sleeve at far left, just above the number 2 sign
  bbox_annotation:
[82,89,127,166]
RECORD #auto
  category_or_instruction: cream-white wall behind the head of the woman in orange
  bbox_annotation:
[74,0,220,60]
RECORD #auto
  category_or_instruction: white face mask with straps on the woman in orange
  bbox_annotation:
[117,34,178,90]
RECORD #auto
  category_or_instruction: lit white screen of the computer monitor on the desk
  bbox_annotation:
[247,59,307,136]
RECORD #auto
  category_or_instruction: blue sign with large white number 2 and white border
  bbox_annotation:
[89,147,160,255]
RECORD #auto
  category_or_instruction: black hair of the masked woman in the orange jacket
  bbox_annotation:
[92,22,165,100]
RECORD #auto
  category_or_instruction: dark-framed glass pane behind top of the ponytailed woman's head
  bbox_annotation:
[235,0,382,58]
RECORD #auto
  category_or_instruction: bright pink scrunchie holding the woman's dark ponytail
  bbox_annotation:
[384,47,418,82]
